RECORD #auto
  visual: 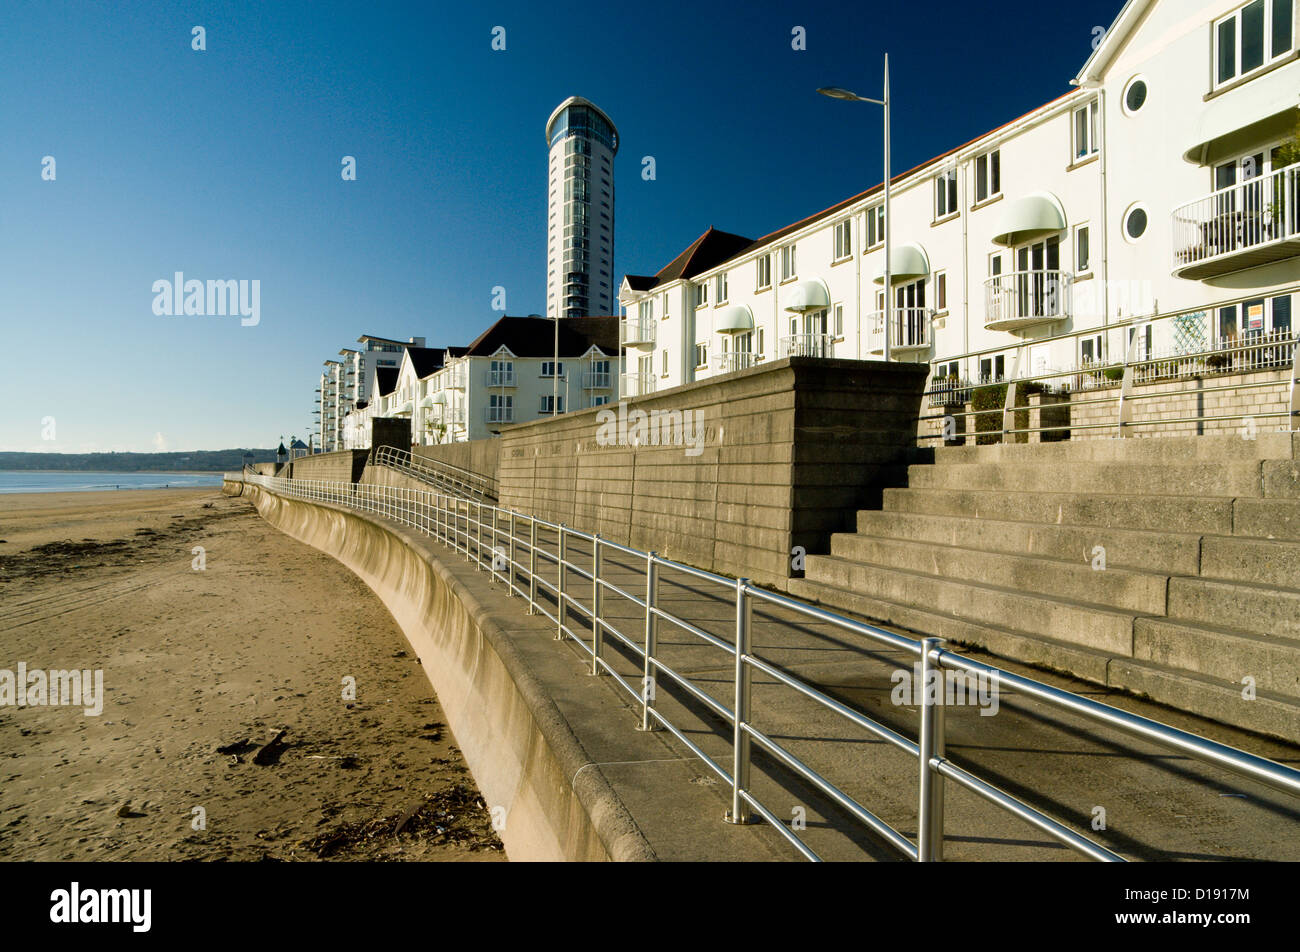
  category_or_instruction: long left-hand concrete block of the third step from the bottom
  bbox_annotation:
[831,533,1166,615]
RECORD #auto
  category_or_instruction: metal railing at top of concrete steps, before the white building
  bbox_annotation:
[918,287,1300,441]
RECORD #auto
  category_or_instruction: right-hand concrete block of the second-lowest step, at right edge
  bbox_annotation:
[1134,618,1300,697]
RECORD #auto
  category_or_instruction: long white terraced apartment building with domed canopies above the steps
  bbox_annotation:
[619,0,1300,395]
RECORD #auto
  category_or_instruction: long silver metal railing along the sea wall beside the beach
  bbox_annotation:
[233,475,1300,861]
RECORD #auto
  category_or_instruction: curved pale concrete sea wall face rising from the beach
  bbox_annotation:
[236,484,655,860]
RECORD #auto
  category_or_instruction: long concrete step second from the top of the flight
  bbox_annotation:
[907,459,1258,497]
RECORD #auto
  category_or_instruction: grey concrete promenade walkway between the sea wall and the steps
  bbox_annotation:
[244,478,1300,861]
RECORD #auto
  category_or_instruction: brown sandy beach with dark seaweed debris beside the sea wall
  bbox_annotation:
[0,489,504,861]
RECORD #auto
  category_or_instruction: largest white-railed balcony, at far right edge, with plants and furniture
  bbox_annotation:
[1171,164,1300,281]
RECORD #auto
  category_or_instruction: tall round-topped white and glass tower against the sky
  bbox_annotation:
[546,96,619,317]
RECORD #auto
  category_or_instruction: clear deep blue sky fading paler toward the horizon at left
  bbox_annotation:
[0,0,1122,453]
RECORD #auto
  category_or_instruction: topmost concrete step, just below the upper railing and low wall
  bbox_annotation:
[933,430,1300,464]
